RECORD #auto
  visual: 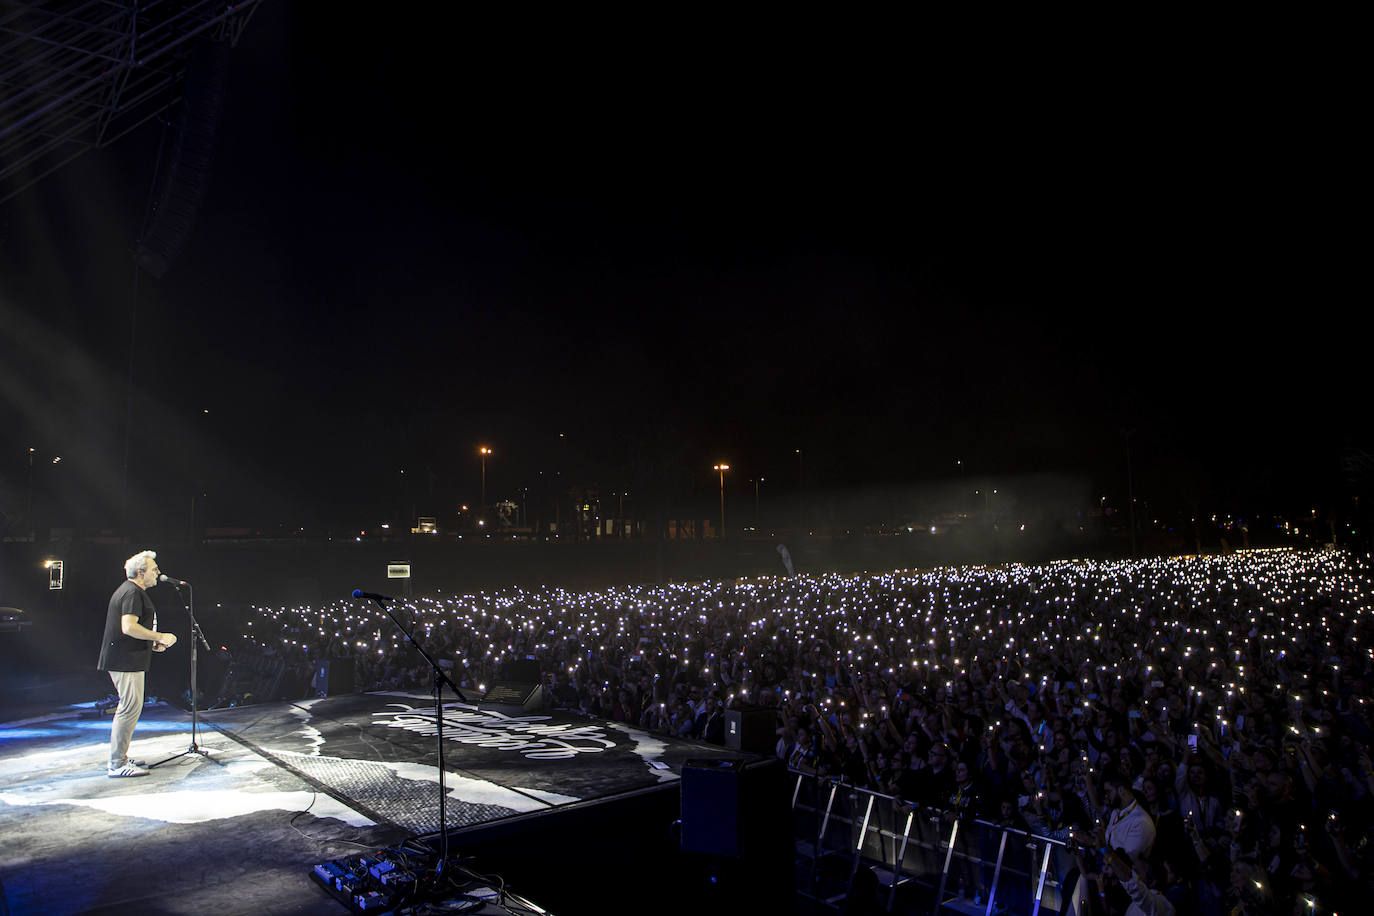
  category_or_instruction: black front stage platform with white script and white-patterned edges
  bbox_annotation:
[205,694,719,834]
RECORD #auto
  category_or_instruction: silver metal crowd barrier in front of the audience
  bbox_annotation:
[790,770,1074,916]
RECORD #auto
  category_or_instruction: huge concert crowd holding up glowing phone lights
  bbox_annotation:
[239,549,1374,916]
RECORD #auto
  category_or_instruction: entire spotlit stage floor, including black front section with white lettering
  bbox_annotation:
[0,694,750,913]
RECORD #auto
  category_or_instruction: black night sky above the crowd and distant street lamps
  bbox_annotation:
[0,7,1369,525]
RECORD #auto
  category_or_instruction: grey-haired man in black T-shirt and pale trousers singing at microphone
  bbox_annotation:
[96,551,176,776]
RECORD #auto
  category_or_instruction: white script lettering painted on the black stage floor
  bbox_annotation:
[372,703,616,761]
